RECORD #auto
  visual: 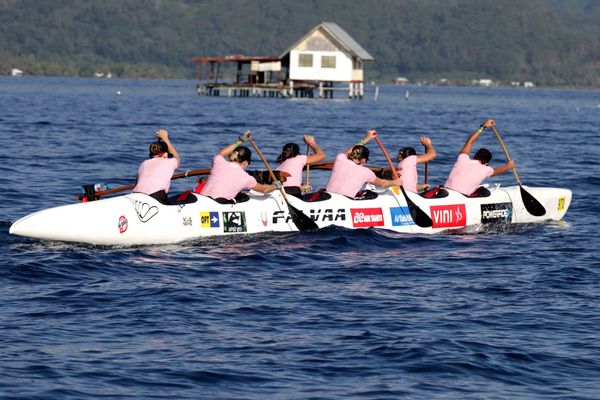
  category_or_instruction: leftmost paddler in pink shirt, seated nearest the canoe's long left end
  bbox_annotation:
[133,129,181,204]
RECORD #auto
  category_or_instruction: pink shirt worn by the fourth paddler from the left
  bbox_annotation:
[326,153,377,197]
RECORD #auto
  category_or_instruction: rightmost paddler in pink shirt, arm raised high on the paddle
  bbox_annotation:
[444,119,515,196]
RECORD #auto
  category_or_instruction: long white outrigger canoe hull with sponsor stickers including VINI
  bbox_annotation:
[10,184,571,246]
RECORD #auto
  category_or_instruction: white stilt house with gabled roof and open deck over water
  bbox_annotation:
[193,22,373,99]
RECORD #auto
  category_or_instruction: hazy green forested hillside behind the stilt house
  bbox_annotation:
[0,0,600,87]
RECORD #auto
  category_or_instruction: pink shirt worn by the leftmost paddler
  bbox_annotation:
[133,157,179,194]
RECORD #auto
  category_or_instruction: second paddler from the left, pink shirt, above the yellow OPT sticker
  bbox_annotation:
[194,132,281,204]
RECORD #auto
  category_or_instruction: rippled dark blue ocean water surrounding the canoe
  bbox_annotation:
[0,77,600,399]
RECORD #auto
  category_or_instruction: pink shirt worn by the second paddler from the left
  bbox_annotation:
[201,155,258,200]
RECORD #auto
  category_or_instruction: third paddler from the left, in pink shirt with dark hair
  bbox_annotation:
[275,135,325,197]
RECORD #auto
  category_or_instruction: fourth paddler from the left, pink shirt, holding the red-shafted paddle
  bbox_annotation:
[326,131,402,198]
